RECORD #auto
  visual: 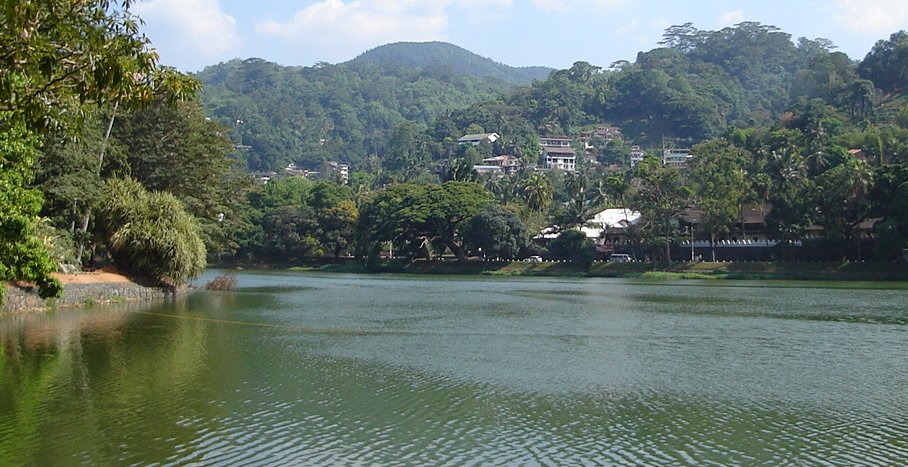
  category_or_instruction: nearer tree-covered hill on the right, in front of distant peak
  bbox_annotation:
[433,22,908,147]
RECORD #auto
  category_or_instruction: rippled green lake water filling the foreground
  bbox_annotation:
[0,272,908,465]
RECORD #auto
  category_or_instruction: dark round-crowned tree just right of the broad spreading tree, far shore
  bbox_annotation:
[463,204,529,259]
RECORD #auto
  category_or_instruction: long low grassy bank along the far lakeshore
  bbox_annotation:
[252,260,908,281]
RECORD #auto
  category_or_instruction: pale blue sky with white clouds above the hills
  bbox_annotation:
[133,0,908,71]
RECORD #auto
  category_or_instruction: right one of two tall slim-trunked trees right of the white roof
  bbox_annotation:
[690,141,751,261]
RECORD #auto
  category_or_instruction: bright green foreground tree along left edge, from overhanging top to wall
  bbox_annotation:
[0,0,158,296]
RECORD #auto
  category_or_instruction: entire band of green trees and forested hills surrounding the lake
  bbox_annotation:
[0,0,908,308]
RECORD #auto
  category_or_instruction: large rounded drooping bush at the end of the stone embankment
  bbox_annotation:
[99,179,206,285]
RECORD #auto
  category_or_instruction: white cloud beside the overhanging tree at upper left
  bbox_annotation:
[133,0,239,67]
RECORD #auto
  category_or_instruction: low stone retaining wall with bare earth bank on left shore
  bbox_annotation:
[0,273,176,314]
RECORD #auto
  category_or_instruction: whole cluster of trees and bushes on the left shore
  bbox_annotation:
[0,0,244,304]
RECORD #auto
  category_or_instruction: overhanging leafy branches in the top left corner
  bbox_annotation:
[0,0,157,127]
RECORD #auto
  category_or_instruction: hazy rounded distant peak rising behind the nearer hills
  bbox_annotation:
[348,42,554,84]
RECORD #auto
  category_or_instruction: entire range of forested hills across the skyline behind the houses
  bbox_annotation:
[199,22,908,173]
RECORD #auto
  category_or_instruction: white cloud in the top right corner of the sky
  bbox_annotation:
[835,0,908,36]
